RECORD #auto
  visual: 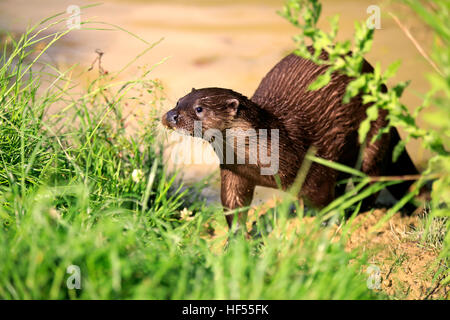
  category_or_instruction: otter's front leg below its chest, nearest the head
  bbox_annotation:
[220,168,255,231]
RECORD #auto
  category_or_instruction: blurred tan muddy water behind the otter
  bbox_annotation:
[0,0,436,205]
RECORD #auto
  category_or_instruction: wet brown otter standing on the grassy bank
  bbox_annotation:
[162,52,418,228]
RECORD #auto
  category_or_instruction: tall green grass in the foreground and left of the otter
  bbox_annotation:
[0,11,380,299]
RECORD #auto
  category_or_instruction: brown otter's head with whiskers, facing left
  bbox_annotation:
[162,88,241,135]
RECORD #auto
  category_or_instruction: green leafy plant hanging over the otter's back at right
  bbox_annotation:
[279,0,450,283]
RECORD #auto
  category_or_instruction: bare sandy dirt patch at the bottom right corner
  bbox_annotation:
[347,210,450,299]
